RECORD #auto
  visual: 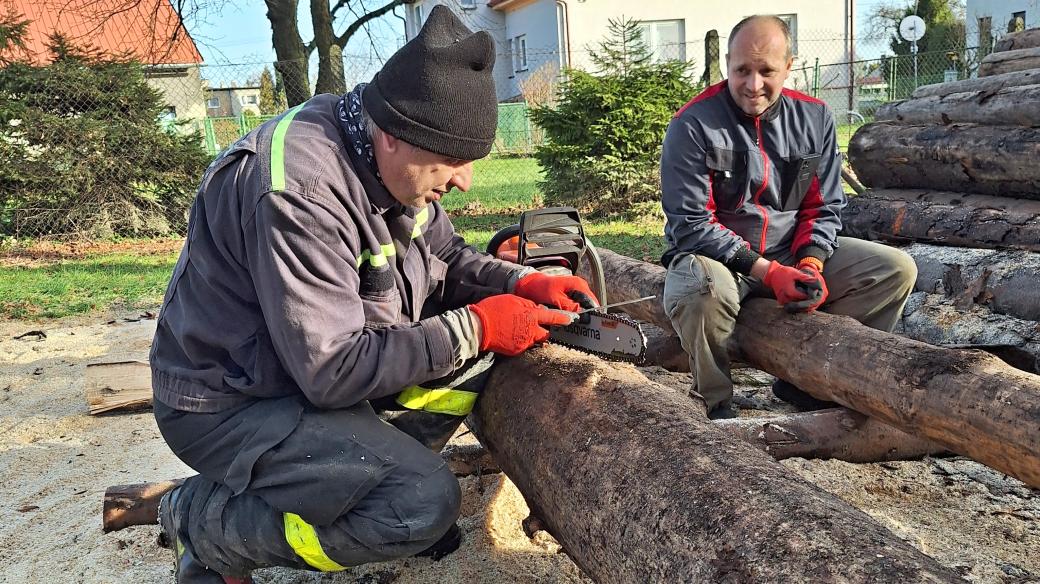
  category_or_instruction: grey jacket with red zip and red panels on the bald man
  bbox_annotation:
[660,80,846,274]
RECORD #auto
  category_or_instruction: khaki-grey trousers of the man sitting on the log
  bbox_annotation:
[664,237,917,412]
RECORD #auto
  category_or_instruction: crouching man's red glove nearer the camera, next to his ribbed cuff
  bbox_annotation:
[469,294,573,356]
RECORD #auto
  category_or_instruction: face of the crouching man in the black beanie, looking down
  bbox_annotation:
[373,131,473,209]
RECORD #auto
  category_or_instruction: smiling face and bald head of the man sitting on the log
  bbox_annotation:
[726,21,794,116]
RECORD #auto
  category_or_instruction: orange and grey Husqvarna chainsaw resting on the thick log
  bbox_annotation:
[488,207,653,364]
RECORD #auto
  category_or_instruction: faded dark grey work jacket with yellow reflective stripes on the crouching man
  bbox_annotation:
[151,95,521,413]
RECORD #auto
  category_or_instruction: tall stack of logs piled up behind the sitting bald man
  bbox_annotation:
[844,24,1040,372]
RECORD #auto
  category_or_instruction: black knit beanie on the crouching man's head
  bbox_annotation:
[362,5,498,160]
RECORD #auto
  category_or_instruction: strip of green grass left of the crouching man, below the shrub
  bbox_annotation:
[0,247,177,319]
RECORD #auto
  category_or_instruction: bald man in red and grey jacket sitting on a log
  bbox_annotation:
[660,16,917,418]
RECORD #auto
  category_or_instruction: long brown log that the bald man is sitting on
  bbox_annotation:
[600,249,1040,487]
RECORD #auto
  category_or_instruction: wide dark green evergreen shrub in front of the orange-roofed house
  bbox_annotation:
[0,30,208,237]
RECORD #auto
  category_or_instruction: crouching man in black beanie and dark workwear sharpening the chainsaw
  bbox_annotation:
[151,6,594,582]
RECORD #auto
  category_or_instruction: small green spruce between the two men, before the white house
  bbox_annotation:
[530,20,697,211]
